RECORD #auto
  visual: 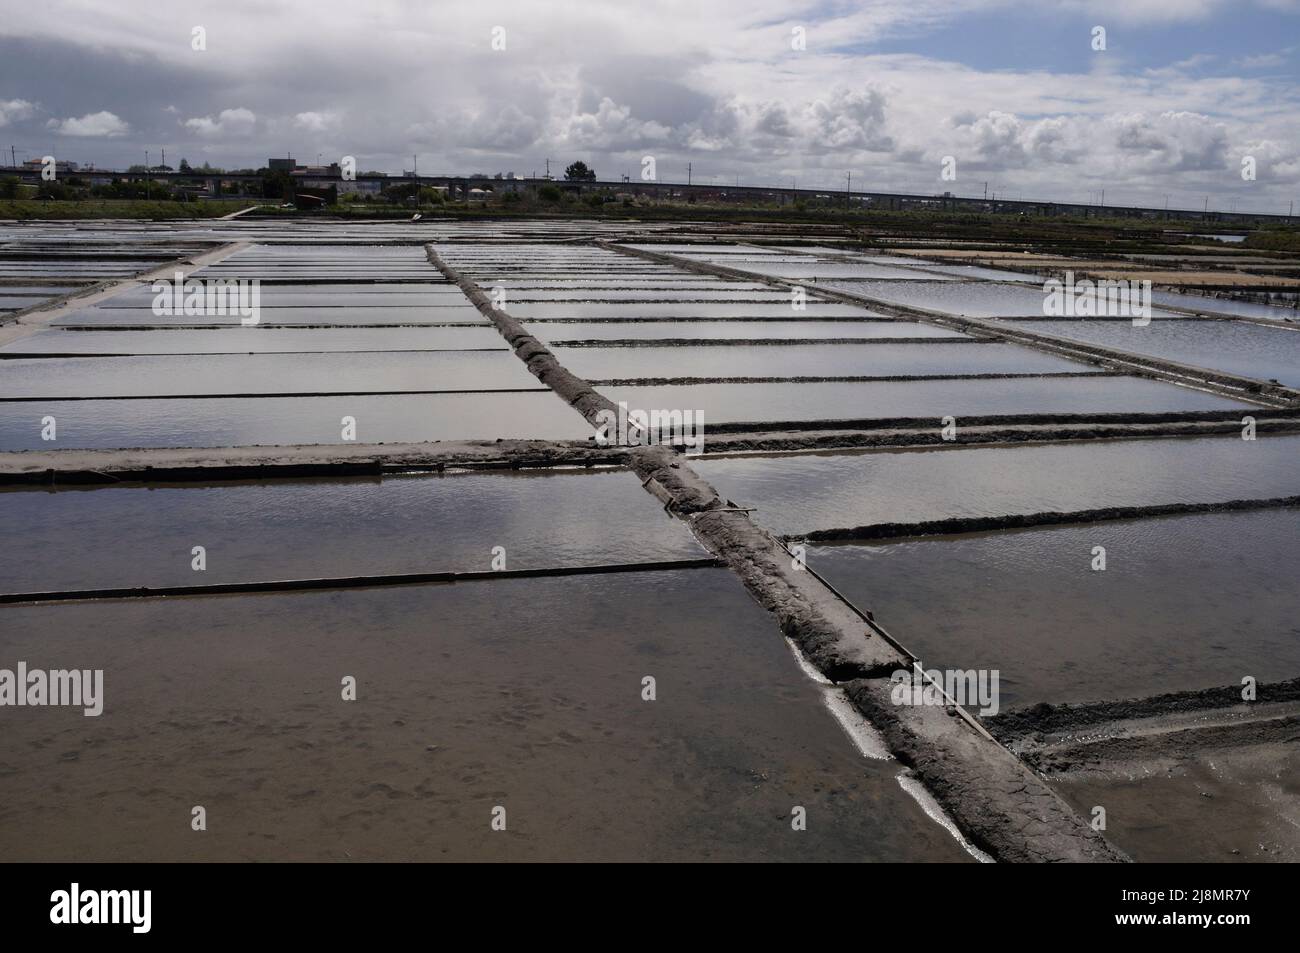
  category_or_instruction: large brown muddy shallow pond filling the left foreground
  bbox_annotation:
[0,569,970,861]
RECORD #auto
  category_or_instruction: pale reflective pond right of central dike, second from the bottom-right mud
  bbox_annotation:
[692,434,1300,536]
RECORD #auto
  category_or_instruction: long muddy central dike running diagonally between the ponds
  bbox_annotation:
[425,244,1128,862]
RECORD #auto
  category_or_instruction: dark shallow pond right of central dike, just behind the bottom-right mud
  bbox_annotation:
[807,510,1300,706]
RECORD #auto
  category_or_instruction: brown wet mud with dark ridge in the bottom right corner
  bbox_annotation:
[987,679,1300,863]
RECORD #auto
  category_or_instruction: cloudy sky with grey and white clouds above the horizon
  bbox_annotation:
[0,0,1300,212]
